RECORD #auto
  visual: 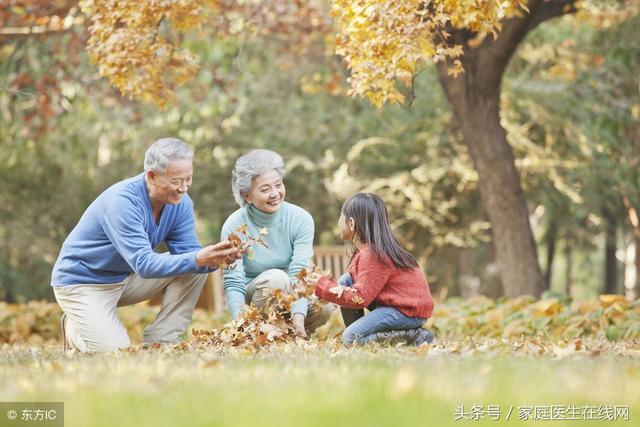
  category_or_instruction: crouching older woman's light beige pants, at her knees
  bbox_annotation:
[245,268,336,333]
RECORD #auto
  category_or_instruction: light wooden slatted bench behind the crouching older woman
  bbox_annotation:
[149,246,349,316]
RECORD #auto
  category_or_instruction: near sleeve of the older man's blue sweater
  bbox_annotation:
[100,196,198,279]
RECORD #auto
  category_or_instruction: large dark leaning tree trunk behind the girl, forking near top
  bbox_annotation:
[438,0,574,297]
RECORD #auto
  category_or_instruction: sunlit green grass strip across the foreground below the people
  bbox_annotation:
[0,344,640,427]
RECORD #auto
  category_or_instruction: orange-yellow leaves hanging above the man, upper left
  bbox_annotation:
[81,0,326,107]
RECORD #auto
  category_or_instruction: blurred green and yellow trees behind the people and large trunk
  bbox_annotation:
[0,1,640,300]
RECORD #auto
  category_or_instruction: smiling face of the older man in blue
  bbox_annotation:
[147,160,193,205]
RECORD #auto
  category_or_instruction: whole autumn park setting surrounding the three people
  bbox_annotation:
[0,0,640,426]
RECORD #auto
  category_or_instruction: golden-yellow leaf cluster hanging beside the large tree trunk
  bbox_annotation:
[332,0,526,107]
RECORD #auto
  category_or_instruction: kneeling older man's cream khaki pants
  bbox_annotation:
[53,274,206,352]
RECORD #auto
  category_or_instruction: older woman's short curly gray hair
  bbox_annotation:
[231,149,284,207]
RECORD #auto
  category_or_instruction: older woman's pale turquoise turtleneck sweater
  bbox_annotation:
[221,202,314,319]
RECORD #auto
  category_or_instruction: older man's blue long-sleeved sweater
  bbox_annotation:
[51,173,210,286]
